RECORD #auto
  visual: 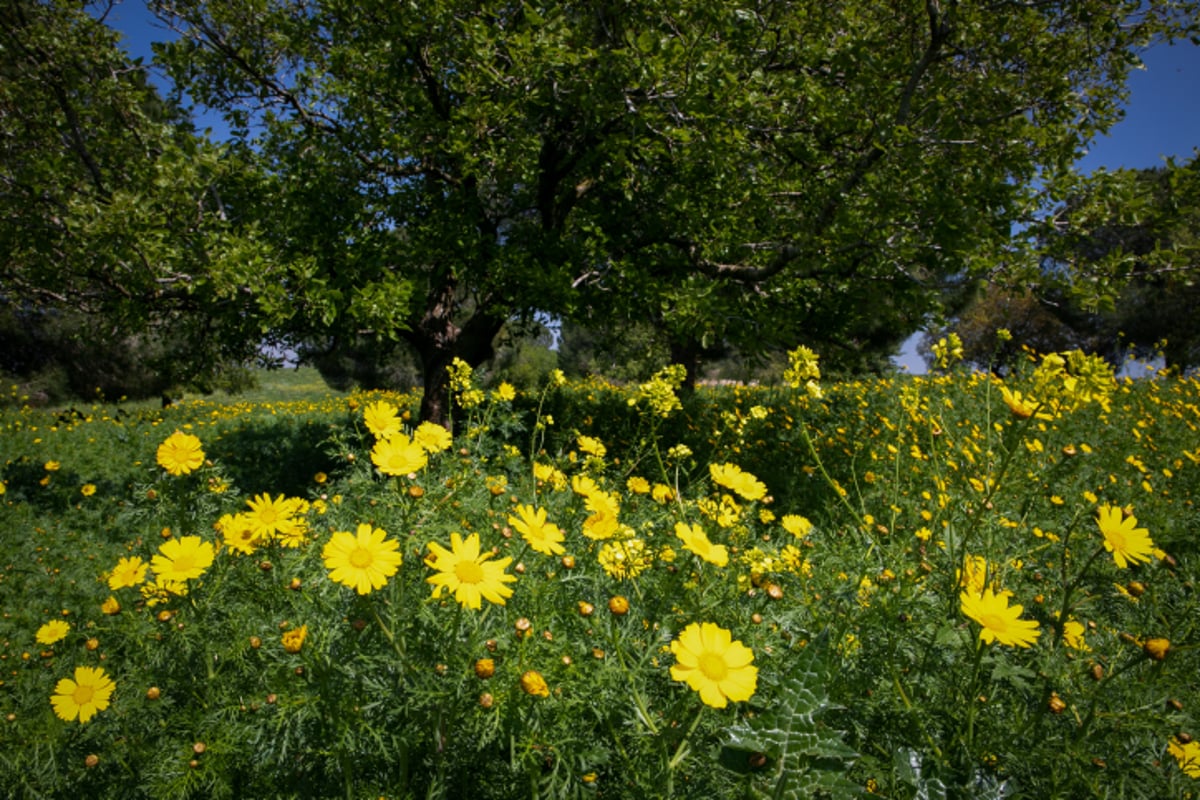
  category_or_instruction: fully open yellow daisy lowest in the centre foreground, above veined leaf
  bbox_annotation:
[671,622,758,709]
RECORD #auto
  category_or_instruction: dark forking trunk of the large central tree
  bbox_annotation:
[403,282,504,427]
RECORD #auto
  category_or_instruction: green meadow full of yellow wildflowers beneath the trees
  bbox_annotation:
[0,352,1200,799]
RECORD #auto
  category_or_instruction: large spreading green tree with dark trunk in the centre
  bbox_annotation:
[147,0,1195,419]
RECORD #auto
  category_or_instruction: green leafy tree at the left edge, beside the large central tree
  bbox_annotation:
[0,0,274,393]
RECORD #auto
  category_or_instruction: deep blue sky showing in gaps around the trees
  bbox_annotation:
[108,0,1200,372]
